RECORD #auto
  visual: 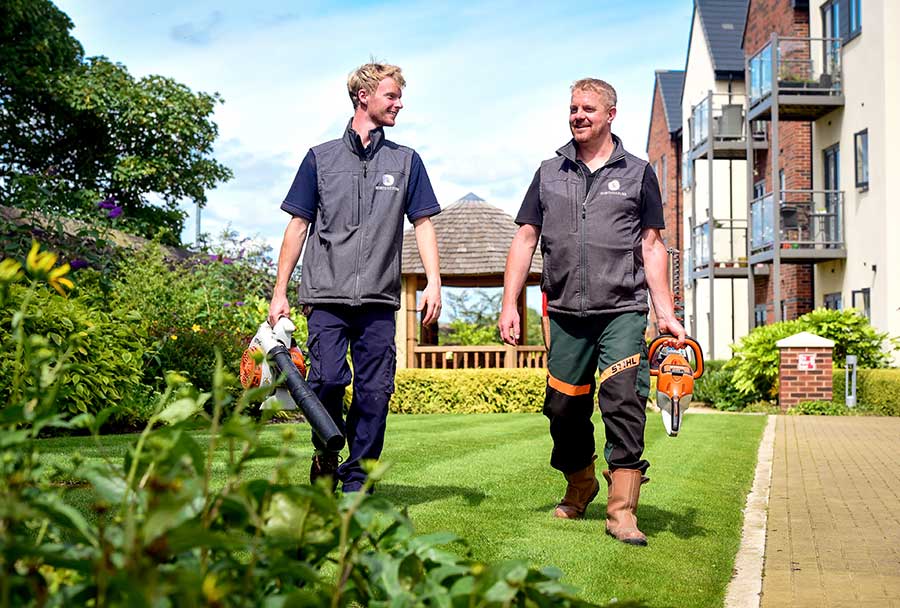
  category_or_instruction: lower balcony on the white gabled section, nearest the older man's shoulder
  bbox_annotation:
[690,219,747,278]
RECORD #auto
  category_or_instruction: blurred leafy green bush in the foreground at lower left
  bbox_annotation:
[0,248,588,608]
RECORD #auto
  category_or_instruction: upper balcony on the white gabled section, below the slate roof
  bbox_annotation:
[689,92,768,159]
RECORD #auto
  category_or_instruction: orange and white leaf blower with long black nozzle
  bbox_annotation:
[241,317,344,452]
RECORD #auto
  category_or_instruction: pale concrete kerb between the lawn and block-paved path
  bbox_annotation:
[725,416,777,608]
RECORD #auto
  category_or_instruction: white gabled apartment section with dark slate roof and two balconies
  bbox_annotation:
[681,0,764,359]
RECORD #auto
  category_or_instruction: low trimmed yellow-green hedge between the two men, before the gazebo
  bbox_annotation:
[390,369,547,414]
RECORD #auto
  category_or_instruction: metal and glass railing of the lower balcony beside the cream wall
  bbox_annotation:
[750,190,844,253]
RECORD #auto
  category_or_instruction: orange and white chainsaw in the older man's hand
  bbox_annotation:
[648,334,703,437]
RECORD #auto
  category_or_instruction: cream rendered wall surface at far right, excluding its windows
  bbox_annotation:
[810,0,900,363]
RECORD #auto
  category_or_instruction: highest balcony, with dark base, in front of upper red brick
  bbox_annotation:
[747,34,844,121]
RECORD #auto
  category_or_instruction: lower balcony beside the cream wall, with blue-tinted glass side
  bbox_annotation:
[750,190,847,264]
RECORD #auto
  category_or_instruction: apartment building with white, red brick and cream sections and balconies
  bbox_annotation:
[648,0,900,358]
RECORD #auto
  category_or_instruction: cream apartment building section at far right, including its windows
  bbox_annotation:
[809,0,900,350]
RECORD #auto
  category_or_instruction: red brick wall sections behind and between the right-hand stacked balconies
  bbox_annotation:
[744,0,813,323]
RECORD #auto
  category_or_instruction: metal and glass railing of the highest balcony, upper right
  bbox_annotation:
[747,36,841,106]
